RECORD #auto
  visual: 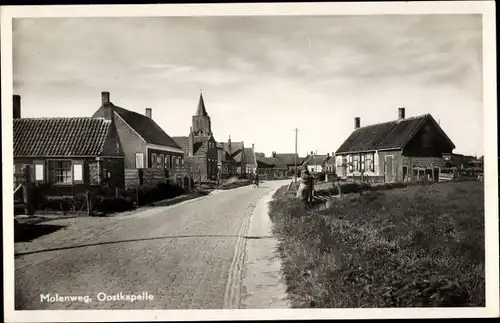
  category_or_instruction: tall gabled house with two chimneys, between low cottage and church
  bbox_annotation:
[92,92,184,169]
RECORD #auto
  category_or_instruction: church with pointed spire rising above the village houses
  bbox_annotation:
[172,93,218,181]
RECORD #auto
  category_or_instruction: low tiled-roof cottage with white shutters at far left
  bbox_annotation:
[13,95,125,195]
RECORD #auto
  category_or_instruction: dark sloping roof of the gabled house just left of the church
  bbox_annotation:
[93,103,181,149]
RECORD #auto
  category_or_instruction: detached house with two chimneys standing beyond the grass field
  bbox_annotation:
[335,107,455,182]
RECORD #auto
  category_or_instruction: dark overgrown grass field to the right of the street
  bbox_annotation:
[270,182,485,308]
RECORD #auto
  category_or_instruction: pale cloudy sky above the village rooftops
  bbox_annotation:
[13,14,483,156]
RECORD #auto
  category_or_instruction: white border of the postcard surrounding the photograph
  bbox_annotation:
[1,1,500,322]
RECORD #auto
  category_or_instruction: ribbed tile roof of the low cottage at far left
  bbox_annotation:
[13,118,111,157]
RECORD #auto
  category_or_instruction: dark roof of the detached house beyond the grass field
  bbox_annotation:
[336,114,455,154]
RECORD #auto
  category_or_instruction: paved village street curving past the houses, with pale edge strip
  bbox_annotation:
[15,180,289,310]
